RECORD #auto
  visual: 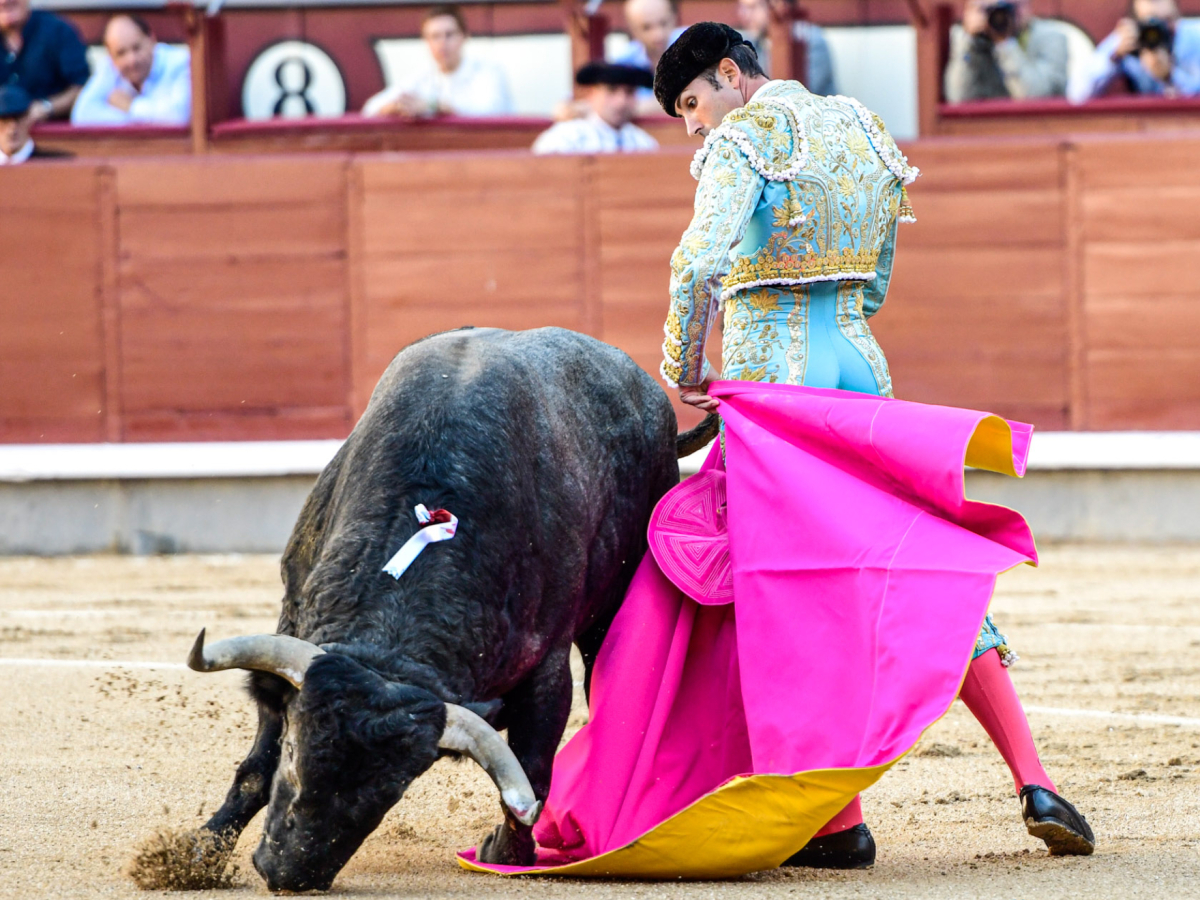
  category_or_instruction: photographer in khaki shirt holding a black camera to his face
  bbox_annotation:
[946,0,1068,103]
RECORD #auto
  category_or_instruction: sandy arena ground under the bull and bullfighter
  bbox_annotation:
[0,547,1200,900]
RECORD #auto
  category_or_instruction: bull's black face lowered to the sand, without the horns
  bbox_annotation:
[254,654,446,890]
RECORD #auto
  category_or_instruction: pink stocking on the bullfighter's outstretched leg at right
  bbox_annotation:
[959,649,1058,793]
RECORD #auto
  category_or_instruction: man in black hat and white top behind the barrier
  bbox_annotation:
[533,62,659,154]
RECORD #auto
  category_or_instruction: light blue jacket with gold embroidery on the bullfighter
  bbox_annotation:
[661,82,919,392]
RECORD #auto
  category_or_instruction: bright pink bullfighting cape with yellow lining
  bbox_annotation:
[460,382,1037,877]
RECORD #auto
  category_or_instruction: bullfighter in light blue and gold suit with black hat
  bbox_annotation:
[654,23,1094,868]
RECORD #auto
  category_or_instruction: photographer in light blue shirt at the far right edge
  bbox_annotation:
[1069,0,1200,103]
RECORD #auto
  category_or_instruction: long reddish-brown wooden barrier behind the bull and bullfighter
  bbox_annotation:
[0,134,1200,442]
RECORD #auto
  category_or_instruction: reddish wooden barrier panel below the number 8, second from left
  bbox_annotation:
[116,157,352,439]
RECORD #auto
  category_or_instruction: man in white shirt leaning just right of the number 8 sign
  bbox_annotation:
[364,0,512,118]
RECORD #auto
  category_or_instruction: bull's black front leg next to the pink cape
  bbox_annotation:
[479,643,571,865]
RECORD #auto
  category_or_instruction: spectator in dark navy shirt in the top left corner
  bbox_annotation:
[0,0,88,122]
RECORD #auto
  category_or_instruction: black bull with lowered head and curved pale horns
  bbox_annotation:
[182,329,715,890]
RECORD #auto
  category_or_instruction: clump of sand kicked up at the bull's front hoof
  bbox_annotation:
[126,829,238,890]
